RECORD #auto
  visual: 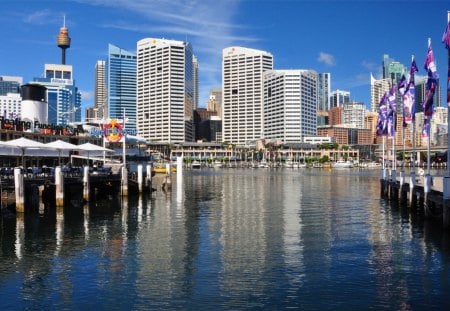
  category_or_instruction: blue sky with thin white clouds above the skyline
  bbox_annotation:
[0,0,450,115]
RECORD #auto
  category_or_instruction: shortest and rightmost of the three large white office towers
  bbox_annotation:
[264,70,318,143]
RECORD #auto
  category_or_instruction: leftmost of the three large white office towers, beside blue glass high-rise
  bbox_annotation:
[137,38,194,143]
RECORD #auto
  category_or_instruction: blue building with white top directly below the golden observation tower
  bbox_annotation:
[33,64,81,125]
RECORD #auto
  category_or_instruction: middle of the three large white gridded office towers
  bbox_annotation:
[222,47,273,145]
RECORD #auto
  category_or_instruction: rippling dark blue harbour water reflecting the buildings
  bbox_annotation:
[0,168,450,310]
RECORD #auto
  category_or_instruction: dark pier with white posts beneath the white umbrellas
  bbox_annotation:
[0,165,155,213]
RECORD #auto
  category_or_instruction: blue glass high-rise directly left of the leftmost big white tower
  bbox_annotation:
[105,44,136,131]
